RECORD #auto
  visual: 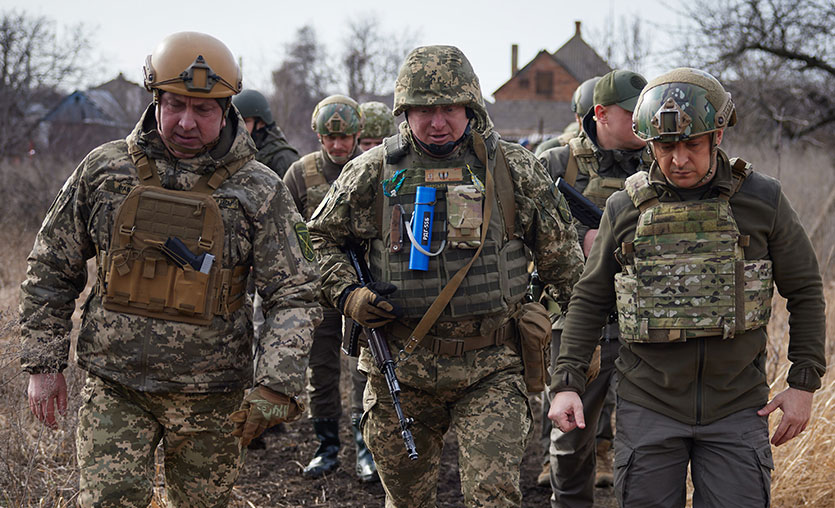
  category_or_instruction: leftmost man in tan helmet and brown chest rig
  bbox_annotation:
[20,32,321,508]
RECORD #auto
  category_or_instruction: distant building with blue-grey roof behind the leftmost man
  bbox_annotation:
[38,73,151,159]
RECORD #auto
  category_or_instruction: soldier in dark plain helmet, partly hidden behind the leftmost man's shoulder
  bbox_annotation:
[232,90,299,178]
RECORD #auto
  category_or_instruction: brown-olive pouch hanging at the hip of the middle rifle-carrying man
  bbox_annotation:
[516,302,551,393]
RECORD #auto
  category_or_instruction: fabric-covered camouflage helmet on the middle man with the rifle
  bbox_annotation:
[394,46,487,125]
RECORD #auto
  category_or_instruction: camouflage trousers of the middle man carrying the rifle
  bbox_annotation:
[360,341,533,508]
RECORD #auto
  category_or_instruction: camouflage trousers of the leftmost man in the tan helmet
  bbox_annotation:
[76,374,243,508]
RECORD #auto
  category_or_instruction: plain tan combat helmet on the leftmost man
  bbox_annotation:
[143,32,242,99]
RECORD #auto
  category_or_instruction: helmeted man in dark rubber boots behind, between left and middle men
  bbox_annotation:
[284,95,377,482]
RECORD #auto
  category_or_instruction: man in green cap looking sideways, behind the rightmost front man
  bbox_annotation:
[539,70,649,508]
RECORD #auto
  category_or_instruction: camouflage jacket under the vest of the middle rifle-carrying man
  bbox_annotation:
[308,122,583,322]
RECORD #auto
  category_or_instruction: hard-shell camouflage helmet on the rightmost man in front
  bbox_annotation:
[632,67,736,142]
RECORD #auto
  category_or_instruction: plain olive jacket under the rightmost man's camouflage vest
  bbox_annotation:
[551,151,826,425]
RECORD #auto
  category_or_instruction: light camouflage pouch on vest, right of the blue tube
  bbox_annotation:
[447,185,484,249]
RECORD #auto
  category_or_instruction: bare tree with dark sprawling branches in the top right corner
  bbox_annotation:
[688,0,835,139]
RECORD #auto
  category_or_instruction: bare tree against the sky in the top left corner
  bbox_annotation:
[0,11,90,158]
